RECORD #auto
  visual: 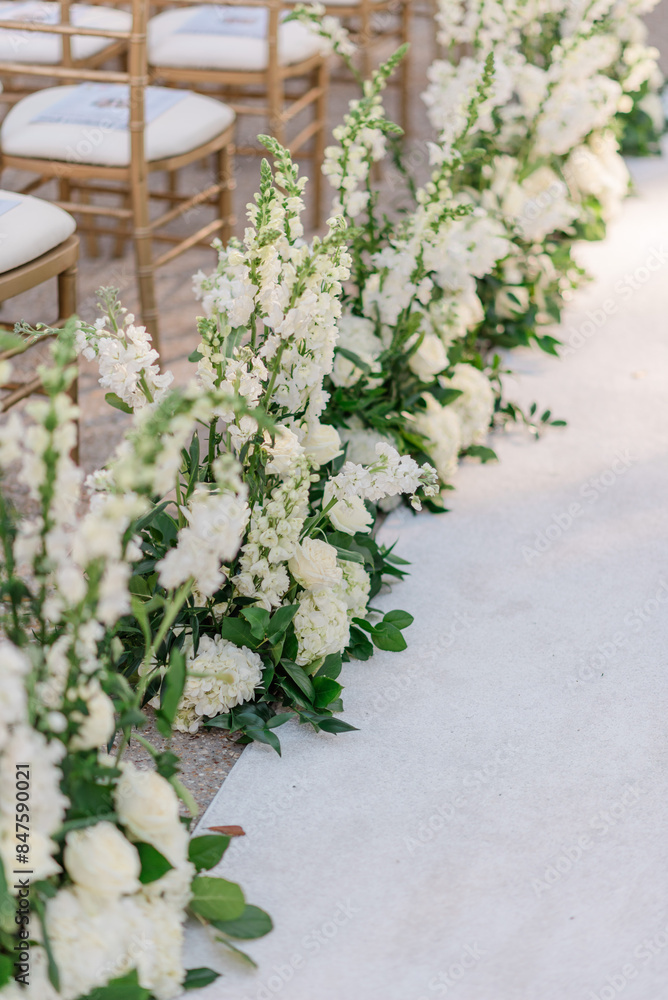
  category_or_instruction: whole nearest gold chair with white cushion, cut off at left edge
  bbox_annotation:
[0,191,79,461]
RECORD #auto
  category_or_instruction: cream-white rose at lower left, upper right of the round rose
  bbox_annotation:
[114,761,188,865]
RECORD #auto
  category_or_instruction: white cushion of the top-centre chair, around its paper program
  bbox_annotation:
[148,7,325,73]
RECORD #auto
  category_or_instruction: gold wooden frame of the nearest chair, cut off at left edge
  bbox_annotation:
[0,236,79,462]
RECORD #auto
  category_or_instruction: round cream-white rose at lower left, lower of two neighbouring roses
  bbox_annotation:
[64,820,141,897]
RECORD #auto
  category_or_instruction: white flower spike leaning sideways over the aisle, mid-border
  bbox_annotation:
[330,443,438,510]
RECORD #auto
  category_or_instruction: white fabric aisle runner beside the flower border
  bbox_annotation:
[181,156,668,1000]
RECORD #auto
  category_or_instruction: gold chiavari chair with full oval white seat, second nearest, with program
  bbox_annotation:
[0,0,235,347]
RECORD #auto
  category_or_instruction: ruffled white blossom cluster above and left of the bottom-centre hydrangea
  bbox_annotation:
[156,487,250,597]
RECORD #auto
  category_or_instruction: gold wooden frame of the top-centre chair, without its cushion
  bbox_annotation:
[149,0,329,229]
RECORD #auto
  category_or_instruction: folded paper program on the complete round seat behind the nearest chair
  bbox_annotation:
[32,83,189,131]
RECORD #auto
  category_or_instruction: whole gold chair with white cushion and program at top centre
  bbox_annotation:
[148,0,329,228]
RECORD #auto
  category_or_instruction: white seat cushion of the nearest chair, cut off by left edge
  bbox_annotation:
[0,190,77,274]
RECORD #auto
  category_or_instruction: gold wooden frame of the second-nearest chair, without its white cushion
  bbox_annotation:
[0,0,234,350]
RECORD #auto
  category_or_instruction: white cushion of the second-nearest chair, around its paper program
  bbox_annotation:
[0,84,235,167]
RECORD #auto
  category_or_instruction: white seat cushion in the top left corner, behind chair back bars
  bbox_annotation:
[0,0,132,66]
